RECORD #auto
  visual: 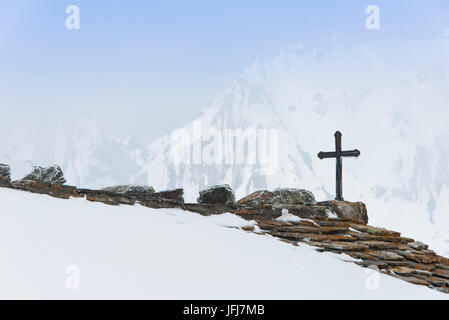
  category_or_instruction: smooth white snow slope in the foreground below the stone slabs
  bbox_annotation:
[0,189,447,299]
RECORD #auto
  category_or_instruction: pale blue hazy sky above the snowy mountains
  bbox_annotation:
[0,0,449,139]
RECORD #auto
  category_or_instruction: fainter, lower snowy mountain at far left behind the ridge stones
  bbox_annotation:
[0,114,150,187]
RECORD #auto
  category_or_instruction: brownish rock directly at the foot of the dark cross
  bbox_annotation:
[317,200,368,224]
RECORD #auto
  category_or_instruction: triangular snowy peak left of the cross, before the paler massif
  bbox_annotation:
[132,79,316,200]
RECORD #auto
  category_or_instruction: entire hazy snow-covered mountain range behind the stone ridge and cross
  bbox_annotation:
[0,37,449,256]
